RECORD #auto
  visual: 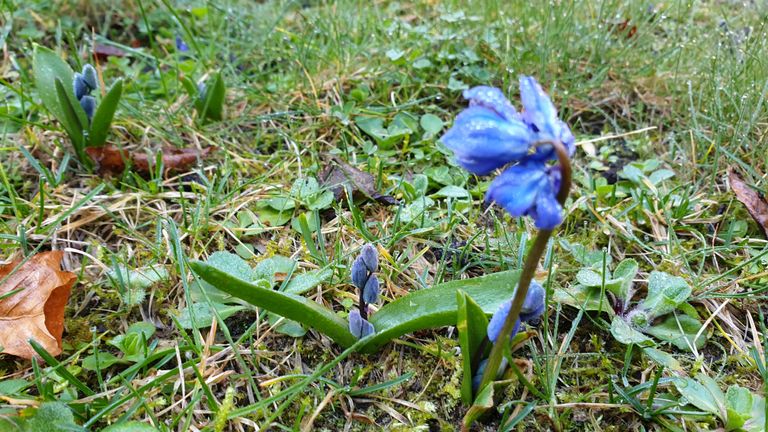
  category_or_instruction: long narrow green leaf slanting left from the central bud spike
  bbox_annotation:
[190,261,357,347]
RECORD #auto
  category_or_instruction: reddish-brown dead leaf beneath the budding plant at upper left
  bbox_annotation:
[85,145,215,174]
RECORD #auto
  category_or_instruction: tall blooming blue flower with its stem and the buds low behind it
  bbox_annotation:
[442,76,575,404]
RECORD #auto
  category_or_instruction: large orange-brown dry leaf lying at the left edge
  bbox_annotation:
[0,251,77,359]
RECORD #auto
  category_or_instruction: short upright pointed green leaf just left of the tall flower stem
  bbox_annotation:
[456,289,488,405]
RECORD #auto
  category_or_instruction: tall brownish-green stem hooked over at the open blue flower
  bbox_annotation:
[478,141,571,394]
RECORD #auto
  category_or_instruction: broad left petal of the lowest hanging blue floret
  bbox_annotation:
[485,161,549,217]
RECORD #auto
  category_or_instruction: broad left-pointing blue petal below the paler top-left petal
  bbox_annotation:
[441,106,533,175]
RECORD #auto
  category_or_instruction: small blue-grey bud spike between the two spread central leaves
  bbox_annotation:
[349,243,379,339]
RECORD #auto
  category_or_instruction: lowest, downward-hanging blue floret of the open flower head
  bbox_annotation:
[485,159,563,229]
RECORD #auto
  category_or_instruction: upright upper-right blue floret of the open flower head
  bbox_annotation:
[520,76,576,160]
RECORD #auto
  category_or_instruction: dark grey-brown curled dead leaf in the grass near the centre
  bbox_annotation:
[320,157,399,205]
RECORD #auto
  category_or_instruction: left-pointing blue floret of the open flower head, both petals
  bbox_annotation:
[440,87,533,175]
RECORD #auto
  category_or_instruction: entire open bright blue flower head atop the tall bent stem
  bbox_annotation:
[441,76,575,229]
